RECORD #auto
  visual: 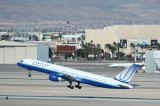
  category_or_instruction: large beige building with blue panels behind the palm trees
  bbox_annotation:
[86,25,160,54]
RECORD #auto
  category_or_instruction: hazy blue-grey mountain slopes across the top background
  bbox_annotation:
[0,0,160,25]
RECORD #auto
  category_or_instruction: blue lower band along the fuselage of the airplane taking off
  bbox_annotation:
[17,62,126,89]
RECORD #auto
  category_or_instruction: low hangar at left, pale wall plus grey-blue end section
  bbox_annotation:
[0,41,49,64]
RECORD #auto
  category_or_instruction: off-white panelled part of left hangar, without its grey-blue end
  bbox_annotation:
[0,41,37,64]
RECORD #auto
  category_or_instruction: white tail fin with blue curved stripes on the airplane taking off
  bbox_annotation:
[114,64,139,83]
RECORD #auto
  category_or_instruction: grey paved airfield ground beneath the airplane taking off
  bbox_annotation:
[0,63,160,106]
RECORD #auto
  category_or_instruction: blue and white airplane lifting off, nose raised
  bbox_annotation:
[17,59,139,89]
